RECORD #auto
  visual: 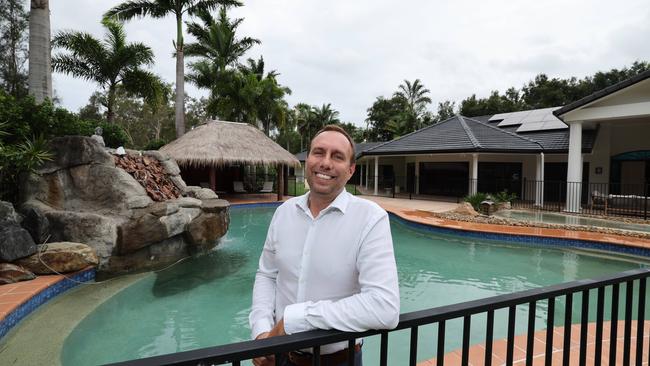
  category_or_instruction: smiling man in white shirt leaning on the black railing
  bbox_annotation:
[249,126,399,366]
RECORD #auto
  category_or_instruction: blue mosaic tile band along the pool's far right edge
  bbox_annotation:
[389,212,650,258]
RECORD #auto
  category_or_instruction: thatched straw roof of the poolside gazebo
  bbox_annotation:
[160,121,300,167]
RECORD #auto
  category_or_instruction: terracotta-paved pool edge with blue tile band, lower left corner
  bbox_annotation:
[0,267,96,340]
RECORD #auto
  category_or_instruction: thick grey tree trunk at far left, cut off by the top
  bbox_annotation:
[29,0,52,103]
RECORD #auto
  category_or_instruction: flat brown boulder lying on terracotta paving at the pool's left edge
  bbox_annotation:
[15,242,99,275]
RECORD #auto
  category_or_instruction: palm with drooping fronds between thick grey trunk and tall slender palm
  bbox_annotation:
[52,19,164,123]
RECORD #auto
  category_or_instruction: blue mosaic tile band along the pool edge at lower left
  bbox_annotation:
[0,268,95,338]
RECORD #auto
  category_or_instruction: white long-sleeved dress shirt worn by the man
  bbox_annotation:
[249,190,399,354]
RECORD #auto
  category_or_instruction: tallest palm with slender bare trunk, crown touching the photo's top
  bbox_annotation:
[105,0,242,137]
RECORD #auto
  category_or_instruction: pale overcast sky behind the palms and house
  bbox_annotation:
[50,0,650,125]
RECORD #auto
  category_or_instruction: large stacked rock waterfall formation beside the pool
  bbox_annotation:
[21,137,229,274]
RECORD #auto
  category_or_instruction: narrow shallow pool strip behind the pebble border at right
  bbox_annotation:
[494,210,650,233]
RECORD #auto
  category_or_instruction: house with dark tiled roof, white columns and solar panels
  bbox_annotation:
[357,71,650,212]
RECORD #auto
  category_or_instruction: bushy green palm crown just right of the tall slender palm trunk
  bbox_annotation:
[185,6,264,71]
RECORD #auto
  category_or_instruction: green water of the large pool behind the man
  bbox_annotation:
[61,207,648,365]
